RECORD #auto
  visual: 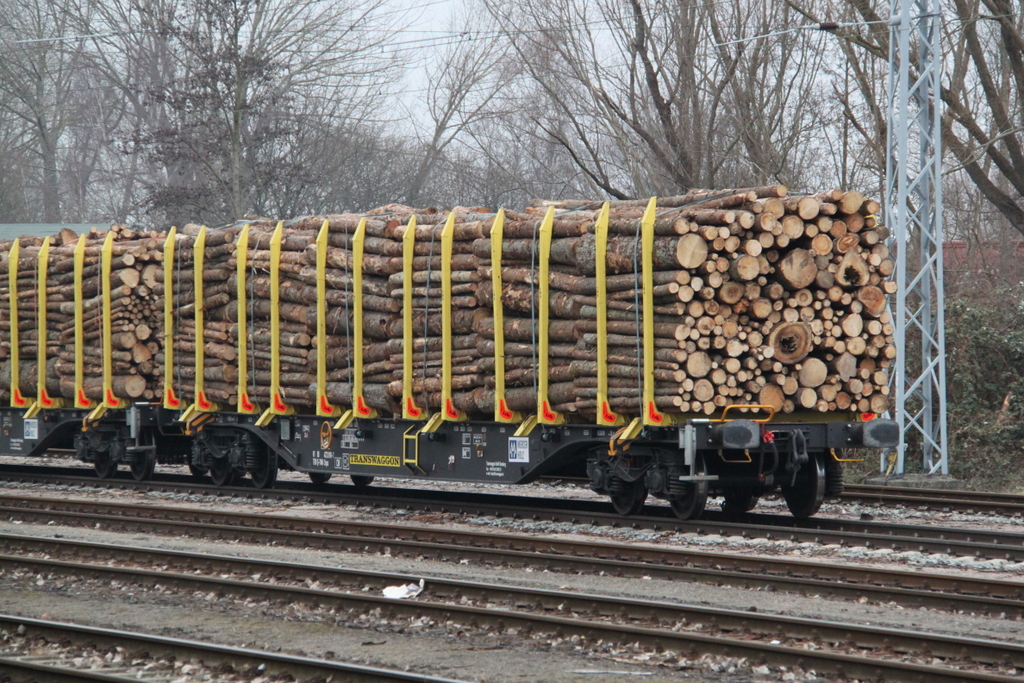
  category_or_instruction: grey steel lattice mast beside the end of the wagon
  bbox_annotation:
[886,0,949,474]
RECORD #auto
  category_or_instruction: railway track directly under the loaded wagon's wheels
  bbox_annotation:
[2,467,1024,562]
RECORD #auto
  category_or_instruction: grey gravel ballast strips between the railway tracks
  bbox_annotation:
[0,473,1024,682]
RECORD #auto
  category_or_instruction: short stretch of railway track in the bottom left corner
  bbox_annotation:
[0,614,458,683]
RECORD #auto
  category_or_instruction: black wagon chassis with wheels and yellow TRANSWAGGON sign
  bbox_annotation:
[0,403,899,518]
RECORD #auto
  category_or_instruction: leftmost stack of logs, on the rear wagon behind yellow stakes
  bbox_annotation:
[0,225,165,403]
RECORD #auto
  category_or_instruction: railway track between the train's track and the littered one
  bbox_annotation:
[0,497,1024,616]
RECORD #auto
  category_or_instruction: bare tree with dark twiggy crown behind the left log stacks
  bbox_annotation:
[71,0,394,222]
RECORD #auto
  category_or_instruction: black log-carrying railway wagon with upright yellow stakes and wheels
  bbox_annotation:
[0,195,899,519]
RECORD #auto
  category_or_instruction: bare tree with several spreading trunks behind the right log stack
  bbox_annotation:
[488,0,821,197]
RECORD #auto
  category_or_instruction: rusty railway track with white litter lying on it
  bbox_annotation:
[0,538,1024,681]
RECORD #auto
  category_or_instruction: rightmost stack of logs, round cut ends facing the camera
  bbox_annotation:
[507,185,895,419]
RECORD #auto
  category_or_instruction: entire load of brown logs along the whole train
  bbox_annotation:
[0,185,895,421]
